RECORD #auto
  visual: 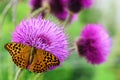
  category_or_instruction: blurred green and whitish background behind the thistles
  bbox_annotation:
[0,0,120,80]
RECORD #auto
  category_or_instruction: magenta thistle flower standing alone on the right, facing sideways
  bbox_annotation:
[76,24,111,64]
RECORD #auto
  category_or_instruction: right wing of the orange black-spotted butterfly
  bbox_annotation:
[29,49,60,73]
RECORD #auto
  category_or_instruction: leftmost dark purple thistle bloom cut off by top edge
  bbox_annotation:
[30,0,43,11]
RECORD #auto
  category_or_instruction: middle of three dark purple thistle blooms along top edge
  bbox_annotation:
[49,0,68,20]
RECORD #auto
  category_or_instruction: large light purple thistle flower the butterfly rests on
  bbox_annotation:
[12,18,69,69]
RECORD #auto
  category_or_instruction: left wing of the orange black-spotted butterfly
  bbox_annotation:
[5,42,31,69]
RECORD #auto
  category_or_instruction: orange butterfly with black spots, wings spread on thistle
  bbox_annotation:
[5,42,60,73]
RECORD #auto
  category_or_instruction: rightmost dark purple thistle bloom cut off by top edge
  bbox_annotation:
[68,0,93,13]
